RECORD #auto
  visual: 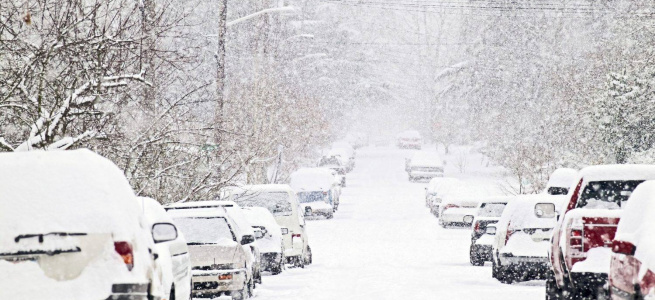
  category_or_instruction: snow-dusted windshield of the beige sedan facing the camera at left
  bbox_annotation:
[175,217,236,245]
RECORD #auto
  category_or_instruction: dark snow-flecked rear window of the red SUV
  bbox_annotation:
[577,180,643,209]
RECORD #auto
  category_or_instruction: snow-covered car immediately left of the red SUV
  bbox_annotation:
[489,194,566,283]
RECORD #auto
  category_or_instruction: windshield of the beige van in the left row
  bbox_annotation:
[233,191,293,216]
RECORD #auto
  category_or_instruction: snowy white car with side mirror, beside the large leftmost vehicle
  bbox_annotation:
[139,197,191,300]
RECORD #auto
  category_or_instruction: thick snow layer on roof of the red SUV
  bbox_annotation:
[579,165,655,182]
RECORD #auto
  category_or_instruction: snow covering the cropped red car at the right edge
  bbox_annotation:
[615,181,655,271]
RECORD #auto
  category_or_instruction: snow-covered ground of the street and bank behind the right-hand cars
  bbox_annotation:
[255,147,544,300]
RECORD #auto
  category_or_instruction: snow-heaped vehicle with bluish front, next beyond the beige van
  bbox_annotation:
[290,168,339,219]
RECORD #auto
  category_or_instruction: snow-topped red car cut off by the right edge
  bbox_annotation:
[609,181,655,300]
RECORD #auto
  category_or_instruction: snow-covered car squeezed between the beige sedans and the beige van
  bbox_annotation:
[238,207,286,275]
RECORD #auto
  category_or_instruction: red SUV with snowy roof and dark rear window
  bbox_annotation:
[546,165,655,299]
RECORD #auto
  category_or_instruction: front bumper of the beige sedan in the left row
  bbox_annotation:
[191,269,246,296]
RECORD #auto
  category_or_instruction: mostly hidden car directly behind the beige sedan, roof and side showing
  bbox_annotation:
[165,201,262,289]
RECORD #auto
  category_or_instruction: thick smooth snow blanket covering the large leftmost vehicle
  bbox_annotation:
[0,149,142,245]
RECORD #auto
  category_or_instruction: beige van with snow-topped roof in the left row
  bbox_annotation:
[225,184,312,268]
